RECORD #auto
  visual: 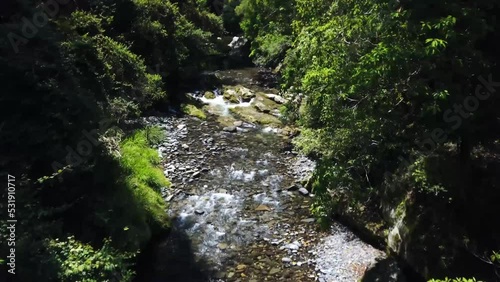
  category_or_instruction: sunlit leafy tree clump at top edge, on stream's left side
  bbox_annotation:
[128,0,222,77]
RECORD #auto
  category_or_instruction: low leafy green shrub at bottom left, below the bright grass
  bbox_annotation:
[48,237,135,282]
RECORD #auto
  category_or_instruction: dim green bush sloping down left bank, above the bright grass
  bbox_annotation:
[61,30,165,120]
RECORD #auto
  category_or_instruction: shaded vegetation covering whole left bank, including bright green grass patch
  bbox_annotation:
[0,0,222,281]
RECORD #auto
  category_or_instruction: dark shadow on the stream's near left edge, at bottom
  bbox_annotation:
[134,223,213,282]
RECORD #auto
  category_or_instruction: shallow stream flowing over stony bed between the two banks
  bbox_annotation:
[135,69,408,282]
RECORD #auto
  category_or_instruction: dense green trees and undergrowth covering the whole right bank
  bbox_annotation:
[236,0,500,280]
